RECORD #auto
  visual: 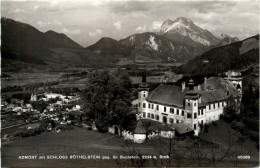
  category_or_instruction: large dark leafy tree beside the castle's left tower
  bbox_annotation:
[82,69,132,134]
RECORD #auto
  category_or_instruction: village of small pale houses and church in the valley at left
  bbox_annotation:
[1,91,84,141]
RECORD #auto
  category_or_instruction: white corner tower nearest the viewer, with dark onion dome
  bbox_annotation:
[184,79,199,135]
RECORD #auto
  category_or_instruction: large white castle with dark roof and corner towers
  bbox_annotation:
[138,77,242,135]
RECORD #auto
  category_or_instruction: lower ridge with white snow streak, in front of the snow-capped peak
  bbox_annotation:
[119,32,199,62]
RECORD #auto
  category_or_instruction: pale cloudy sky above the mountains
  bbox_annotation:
[1,0,259,47]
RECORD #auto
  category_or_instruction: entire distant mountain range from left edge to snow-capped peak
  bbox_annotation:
[1,17,254,65]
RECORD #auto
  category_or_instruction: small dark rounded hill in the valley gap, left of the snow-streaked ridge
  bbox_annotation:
[86,37,131,56]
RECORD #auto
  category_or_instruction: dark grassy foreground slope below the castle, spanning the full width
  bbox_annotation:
[2,122,258,167]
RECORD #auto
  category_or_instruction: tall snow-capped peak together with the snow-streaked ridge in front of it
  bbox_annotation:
[119,17,219,62]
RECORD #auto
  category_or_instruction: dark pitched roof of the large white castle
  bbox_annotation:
[146,77,239,107]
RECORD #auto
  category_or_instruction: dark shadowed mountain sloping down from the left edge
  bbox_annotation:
[1,17,86,64]
